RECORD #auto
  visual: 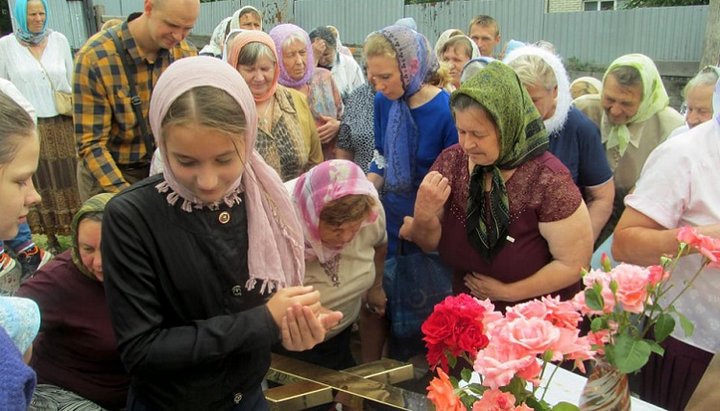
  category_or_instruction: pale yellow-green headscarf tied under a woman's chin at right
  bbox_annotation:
[602,54,670,156]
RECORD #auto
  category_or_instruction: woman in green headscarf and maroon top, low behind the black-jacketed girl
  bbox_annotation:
[17,193,129,410]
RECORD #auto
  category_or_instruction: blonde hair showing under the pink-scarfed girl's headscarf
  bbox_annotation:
[162,86,247,137]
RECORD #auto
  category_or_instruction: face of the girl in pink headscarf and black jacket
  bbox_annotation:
[163,123,245,203]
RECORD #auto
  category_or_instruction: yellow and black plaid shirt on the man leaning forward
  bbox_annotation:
[73,14,197,192]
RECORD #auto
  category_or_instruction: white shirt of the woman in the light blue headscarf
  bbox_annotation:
[0,31,73,118]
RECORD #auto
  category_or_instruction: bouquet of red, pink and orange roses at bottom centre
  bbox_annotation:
[422,294,593,411]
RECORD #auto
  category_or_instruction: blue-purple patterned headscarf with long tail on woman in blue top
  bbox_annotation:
[378,25,438,193]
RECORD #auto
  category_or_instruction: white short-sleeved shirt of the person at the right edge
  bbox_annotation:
[625,120,720,353]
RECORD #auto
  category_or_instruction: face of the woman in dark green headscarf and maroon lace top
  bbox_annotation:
[455,107,500,170]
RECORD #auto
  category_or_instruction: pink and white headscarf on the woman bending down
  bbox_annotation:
[292,160,380,283]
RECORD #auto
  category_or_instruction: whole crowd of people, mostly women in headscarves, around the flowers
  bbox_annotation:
[0,0,720,410]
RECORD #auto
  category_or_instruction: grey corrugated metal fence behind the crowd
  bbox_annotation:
[9,0,708,65]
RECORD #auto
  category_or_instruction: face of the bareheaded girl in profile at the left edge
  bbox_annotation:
[0,133,40,240]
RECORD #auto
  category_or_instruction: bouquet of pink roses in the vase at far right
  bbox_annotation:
[573,227,720,374]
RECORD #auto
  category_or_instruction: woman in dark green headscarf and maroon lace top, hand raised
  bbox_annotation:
[401,62,592,309]
